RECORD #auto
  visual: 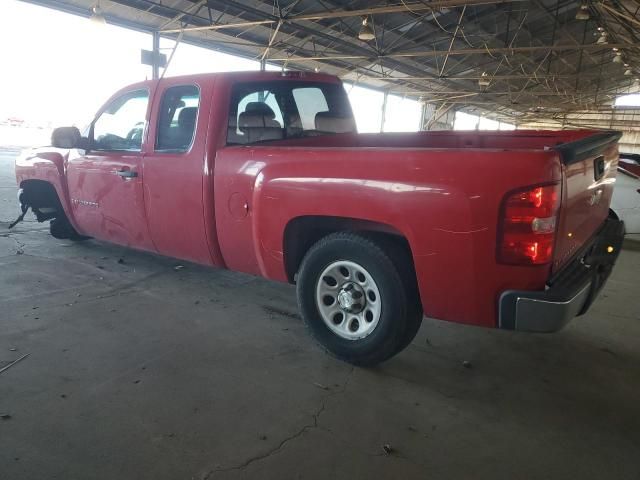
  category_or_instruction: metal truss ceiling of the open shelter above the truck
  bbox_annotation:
[17,0,640,126]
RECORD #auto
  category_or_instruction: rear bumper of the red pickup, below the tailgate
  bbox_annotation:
[498,218,624,332]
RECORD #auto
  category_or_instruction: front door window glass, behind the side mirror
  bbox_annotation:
[93,90,149,152]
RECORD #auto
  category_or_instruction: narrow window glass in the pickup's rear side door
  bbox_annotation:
[155,85,200,152]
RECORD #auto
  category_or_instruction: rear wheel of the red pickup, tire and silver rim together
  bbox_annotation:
[297,233,422,366]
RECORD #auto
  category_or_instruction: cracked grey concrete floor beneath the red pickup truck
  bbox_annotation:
[0,150,640,480]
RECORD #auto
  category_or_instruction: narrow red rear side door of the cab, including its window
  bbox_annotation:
[144,78,214,265]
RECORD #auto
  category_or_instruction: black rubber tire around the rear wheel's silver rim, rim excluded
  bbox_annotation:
[297,232,422,366]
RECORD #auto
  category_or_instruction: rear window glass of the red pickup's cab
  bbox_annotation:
[227,81,356,145]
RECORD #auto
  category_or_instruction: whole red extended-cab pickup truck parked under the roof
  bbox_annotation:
[16,72,623,365]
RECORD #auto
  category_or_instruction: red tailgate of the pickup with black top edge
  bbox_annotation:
[552,131,622,272]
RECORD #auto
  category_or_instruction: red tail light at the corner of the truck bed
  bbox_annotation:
[498,184,560,265]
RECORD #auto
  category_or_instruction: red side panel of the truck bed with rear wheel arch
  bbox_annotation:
[215,142,561,326]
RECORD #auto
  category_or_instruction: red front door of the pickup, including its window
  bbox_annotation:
[67,89,155,250]
